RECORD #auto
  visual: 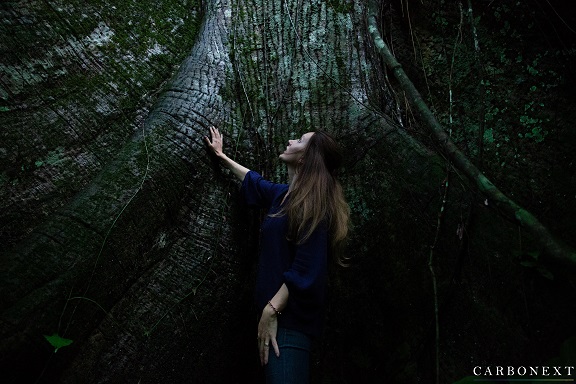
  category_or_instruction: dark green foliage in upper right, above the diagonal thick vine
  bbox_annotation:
[410,1,576,240]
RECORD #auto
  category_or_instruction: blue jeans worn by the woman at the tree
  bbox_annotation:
[264,328,312,384]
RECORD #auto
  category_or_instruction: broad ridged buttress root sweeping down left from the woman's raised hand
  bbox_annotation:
[1,2,247,382]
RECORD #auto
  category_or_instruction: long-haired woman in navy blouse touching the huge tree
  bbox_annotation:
[205,127,349,384]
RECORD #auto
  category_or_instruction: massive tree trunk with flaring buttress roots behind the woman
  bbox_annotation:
[0,0,573,383]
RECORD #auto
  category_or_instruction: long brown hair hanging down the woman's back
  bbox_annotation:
[278,131,350,264]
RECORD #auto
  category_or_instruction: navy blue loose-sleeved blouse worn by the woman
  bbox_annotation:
[241,171,328,337]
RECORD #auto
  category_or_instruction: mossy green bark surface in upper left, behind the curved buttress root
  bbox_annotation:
[0,0,202,246]
